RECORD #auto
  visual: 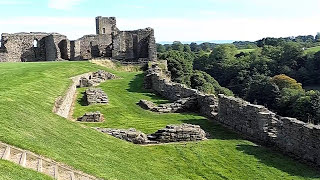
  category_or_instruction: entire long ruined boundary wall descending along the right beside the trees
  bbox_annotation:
[145,61,320,166]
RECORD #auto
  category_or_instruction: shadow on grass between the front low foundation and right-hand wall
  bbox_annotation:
[182,118,243,140]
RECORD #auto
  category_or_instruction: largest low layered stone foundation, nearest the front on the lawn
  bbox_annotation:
[148,124,206,143]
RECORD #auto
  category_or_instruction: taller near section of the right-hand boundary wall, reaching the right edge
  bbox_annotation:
[215,95,320,166]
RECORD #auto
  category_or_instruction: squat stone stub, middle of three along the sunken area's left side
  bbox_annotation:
[84,88,109,105]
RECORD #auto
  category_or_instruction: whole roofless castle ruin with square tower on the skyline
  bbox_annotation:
[0,16,157,62]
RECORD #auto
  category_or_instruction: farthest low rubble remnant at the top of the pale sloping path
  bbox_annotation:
[78,70,116,87]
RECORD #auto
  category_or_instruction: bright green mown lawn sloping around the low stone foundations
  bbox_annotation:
[0,62,320,180]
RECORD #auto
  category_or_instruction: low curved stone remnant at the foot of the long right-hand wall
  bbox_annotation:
[138,97,197,113]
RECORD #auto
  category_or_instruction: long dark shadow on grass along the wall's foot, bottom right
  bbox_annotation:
[237,145,320,178]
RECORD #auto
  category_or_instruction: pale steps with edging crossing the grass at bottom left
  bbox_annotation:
[0,142,98,180]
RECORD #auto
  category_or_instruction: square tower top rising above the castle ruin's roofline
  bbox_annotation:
[96,16,117,35]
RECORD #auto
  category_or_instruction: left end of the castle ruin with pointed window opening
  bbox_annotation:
[0,33,70,62]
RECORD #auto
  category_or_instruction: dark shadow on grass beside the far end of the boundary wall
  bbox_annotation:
[126,73,170,104]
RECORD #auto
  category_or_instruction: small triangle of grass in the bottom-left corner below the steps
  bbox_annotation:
[0,160,52,180]
